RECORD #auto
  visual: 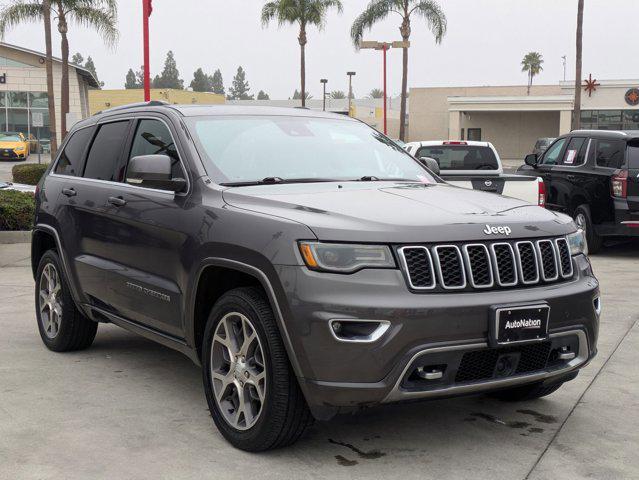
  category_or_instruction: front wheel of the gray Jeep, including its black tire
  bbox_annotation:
[202,287,312,452]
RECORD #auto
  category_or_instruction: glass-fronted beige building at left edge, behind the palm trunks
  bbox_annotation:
[0,43,98,150]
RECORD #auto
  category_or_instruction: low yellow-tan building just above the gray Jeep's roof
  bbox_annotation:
[89,88,225,115]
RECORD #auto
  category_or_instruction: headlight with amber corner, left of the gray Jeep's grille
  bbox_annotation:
[299,242,395,273]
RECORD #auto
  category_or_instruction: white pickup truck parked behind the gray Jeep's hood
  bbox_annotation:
[404,141,546,207]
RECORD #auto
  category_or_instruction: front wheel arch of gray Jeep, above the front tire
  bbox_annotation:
[187,257,303,377]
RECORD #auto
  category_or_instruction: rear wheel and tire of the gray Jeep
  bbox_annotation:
[35,250,98,352]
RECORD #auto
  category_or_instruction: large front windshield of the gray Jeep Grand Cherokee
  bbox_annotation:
[187,116,435,184]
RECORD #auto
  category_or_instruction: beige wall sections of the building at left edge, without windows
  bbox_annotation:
[0,45,88,144]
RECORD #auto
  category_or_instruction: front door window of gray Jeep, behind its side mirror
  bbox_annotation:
[129,120,185,178]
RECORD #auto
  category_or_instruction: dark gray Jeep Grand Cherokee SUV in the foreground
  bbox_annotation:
[32,103,601,451]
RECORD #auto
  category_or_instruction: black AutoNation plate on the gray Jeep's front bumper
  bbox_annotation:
[491,304,550,345]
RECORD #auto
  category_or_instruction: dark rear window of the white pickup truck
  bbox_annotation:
[416,145,499,171]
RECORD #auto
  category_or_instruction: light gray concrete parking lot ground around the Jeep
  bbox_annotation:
[0,242,639,480]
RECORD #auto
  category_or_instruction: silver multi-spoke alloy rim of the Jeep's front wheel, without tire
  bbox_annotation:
[209,312,266,430]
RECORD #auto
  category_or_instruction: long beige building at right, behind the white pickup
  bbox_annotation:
[409,80,639,160]
